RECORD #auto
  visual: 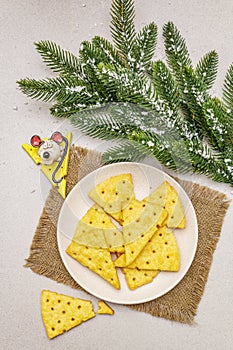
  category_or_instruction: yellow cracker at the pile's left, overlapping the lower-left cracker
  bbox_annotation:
[73,204,124,252]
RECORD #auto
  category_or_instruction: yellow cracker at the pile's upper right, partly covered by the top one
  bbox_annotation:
[146,181,186,228]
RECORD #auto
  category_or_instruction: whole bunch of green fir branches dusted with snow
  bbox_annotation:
[18,0,233,185]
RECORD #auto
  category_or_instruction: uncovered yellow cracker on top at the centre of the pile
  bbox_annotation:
[122,200,167,266]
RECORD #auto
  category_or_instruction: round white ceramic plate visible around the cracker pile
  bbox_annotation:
[57,163,198,304]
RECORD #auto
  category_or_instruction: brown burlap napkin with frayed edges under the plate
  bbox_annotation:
[25,146,229,324]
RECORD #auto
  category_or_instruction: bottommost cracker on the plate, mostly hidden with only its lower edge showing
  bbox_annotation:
[122,267,159,290]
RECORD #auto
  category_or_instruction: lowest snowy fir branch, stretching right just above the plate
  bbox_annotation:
[71,100,233,183]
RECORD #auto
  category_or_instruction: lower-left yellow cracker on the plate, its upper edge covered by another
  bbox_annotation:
[66,241,120,289]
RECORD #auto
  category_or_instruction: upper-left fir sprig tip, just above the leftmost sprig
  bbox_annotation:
[35,40,82,78]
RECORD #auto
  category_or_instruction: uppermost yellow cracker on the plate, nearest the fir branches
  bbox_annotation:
[89,174,135,223]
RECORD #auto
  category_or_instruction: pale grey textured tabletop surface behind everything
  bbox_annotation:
[0,0,233,350]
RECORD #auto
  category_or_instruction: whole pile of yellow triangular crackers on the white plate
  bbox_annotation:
[66,174,186,290]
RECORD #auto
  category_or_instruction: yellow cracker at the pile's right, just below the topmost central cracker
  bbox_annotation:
[115,227,180,271]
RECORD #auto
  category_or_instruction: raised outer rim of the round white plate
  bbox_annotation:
[56,162,198,305]
